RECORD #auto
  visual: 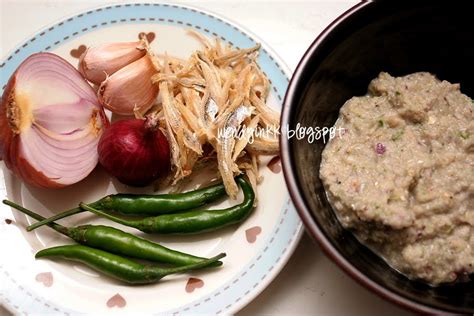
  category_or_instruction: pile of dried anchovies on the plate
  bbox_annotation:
[148,31,279,197]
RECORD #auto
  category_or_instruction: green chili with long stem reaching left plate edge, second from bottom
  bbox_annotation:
[3,200,222,267]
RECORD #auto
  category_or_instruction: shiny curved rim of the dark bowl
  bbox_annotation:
[279,1,460,314]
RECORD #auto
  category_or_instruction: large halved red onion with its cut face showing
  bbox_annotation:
[0,53,108,188]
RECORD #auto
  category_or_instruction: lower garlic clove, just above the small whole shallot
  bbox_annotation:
[98,55,159,115]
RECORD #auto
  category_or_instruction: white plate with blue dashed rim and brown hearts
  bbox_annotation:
[0,4,302,315]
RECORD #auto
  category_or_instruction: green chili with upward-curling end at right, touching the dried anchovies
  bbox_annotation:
[80,177,255,234]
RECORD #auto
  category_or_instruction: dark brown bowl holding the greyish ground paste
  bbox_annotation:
[280,1,474,314]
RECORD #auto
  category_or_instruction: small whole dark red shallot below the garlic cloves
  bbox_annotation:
[98,118,170,186]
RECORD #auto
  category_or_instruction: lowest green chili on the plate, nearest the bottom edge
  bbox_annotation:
[35,245,225,284]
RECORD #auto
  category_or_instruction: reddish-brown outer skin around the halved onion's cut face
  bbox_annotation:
[0,53,108,188]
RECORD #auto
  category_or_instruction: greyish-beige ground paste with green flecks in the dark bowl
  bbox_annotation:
[320,72,474,284]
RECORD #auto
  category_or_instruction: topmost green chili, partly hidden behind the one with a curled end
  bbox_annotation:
[26,183,226,231]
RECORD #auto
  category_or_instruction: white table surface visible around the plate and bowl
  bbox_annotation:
[0,0,408,316]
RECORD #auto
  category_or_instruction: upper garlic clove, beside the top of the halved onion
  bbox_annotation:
[79,40,148,85]
